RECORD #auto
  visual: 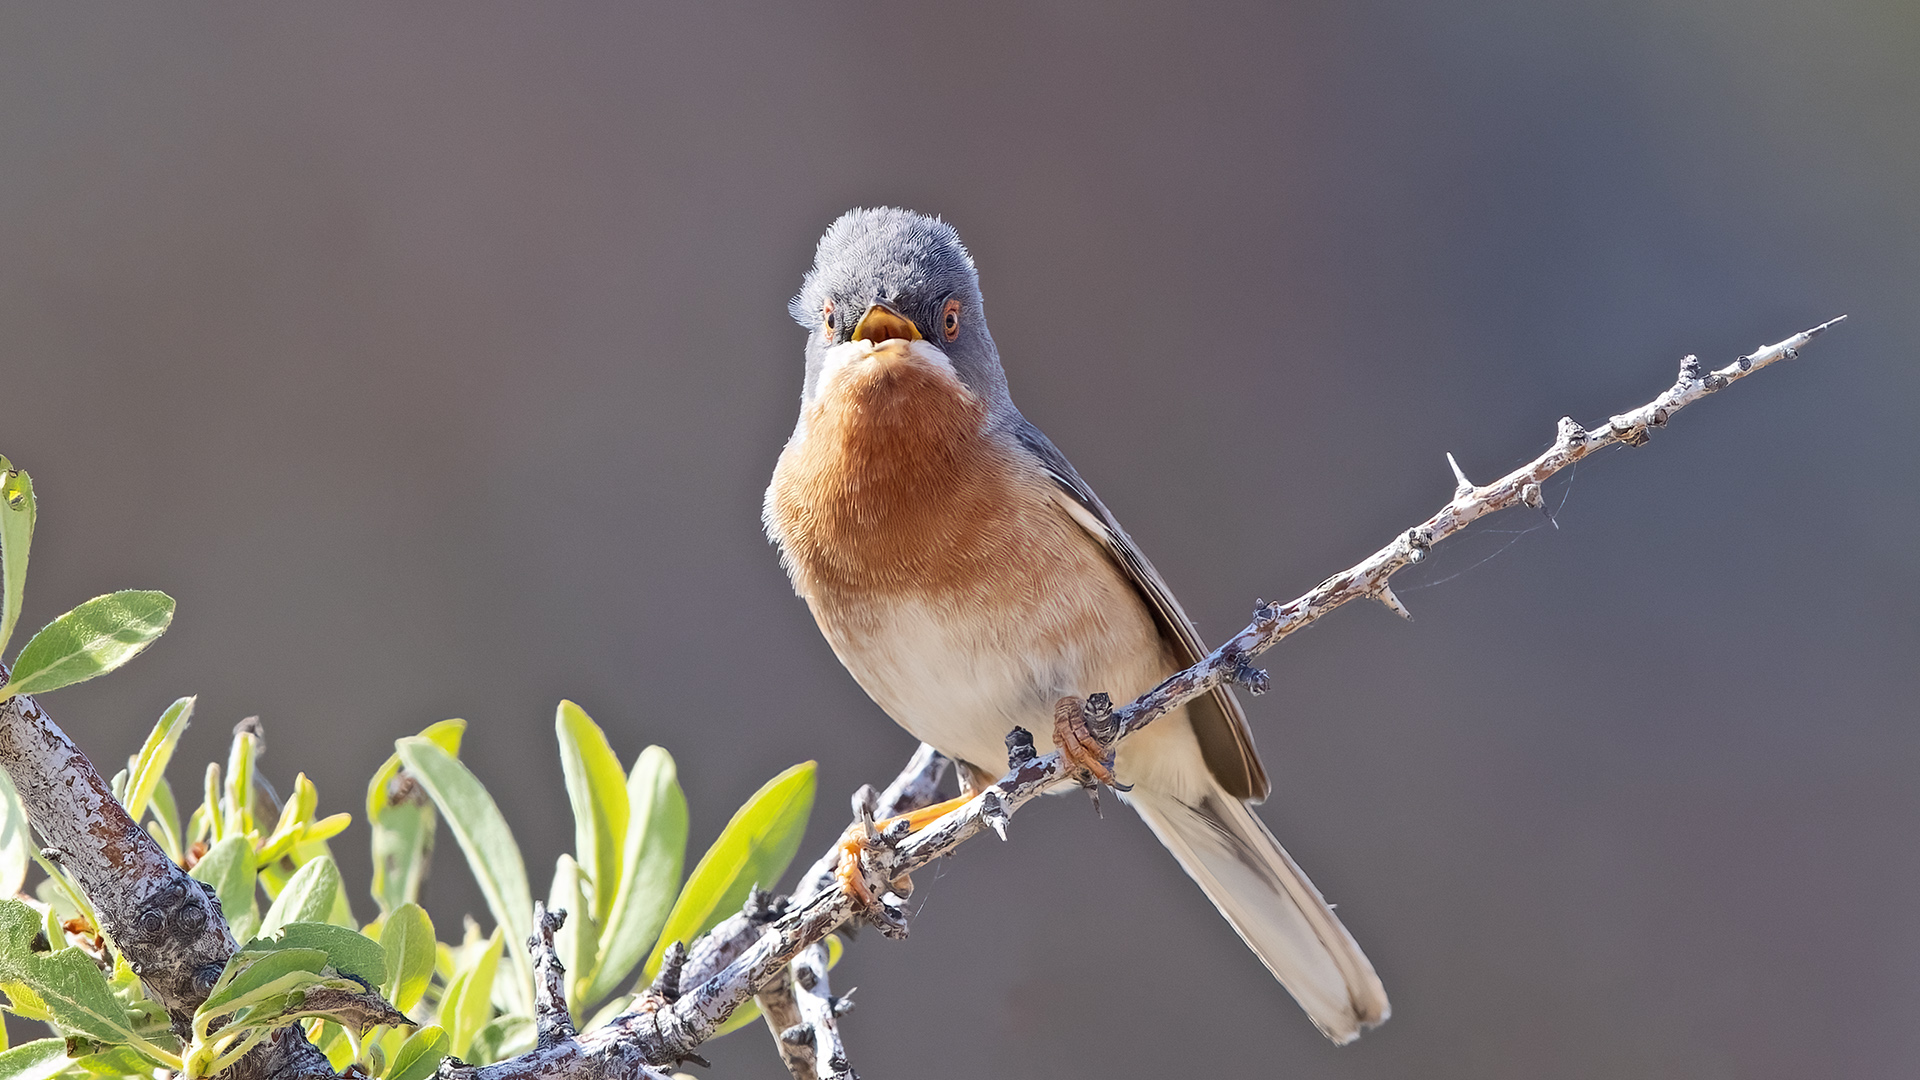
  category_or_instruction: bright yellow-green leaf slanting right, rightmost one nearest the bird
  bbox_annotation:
[641,761,814,980]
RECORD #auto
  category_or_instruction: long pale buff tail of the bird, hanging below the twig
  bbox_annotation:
[1127,788,1390,1043]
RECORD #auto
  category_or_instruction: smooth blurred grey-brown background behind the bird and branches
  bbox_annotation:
[0,0,1920,1078]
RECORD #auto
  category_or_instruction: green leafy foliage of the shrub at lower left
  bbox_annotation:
[0,457,814,1080]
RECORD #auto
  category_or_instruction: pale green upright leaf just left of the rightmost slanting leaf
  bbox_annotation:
[582,746,687,1003]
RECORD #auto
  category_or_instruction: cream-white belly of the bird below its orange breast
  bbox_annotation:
[816,590,1206,792]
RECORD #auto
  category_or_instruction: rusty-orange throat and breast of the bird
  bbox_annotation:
[768,342,1012,596]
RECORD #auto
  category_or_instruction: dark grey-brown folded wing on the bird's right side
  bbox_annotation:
[1014,417,1271,801]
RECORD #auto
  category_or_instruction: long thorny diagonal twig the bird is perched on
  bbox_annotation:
[445,319,1839,1080]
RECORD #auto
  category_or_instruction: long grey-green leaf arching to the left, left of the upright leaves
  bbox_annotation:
[394,736,534,1006]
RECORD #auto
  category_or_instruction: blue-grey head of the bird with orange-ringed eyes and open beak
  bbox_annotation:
[787,208,1018,415]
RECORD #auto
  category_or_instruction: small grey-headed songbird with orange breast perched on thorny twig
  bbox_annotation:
[764,209,1388,1043]
